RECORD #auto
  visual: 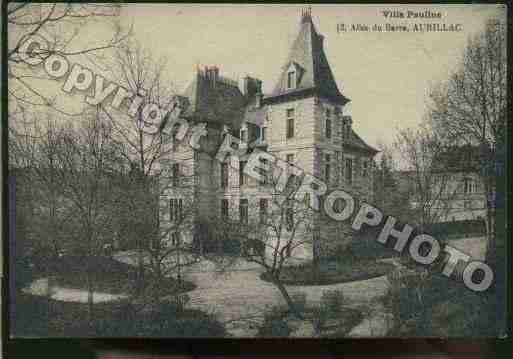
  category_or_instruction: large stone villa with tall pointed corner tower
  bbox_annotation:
[159,11,378,259]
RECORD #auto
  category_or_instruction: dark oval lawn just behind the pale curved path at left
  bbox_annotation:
[39,256,195,294]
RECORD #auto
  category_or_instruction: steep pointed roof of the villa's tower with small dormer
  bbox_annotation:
[267,12,349,105]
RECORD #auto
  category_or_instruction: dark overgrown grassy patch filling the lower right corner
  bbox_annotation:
[383,273,498,338]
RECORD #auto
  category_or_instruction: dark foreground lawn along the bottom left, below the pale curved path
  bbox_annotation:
[10,293,226,338]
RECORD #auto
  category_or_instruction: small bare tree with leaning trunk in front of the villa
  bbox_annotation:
[211,175,316,319]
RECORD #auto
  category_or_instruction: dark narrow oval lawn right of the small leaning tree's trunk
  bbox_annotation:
[260,259,395,285]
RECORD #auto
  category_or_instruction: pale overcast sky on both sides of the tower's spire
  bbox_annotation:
[117,4,505,149]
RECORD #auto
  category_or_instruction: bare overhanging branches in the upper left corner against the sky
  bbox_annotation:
[6,3,131,115]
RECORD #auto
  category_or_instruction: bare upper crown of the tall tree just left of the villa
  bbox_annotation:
[103,38,181,178]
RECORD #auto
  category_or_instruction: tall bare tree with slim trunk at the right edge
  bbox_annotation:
[429,19,507,262]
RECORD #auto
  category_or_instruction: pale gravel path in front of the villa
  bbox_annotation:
[115,252,389,337]
